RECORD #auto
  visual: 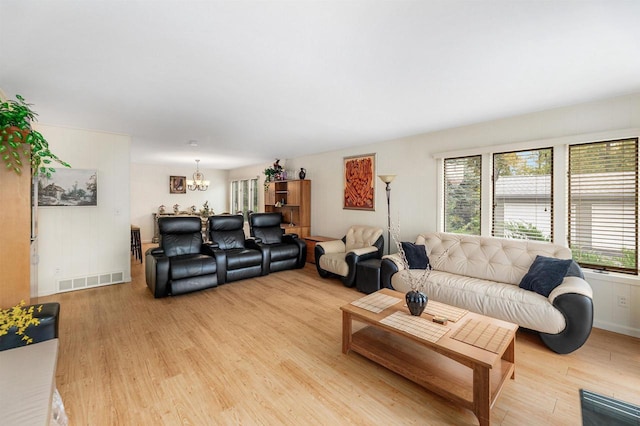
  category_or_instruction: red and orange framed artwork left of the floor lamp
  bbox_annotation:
[343,154,376,211]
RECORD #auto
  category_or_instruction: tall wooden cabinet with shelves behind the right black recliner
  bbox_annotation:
[264,180,311,238]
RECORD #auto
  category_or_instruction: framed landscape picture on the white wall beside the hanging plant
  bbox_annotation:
[38,169,98,207]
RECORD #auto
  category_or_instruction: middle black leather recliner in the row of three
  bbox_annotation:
[209,215,266,284]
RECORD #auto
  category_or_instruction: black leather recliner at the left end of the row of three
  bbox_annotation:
[145,217,218,298]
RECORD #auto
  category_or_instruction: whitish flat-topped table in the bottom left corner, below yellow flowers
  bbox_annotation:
[0,339,58,426]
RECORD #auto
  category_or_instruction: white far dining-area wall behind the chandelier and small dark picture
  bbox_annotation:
[131,162,229,242]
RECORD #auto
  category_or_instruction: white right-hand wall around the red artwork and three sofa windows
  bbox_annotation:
[236,94,640,337]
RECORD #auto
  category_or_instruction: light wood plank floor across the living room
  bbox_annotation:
[38,250,640,425]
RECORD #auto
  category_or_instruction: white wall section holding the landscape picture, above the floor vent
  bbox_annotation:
[37,125,131,296]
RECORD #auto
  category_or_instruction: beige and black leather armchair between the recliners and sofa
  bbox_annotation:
[315,225,384,287]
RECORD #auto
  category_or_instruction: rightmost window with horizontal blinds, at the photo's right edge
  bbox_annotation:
[568,139,638,275]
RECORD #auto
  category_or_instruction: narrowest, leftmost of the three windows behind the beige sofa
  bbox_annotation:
[444,155,482,235]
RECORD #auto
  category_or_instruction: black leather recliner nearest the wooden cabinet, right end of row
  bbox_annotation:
[249,213,307,273]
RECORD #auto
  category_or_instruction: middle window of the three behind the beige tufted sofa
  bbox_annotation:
[492,148,553,241]
